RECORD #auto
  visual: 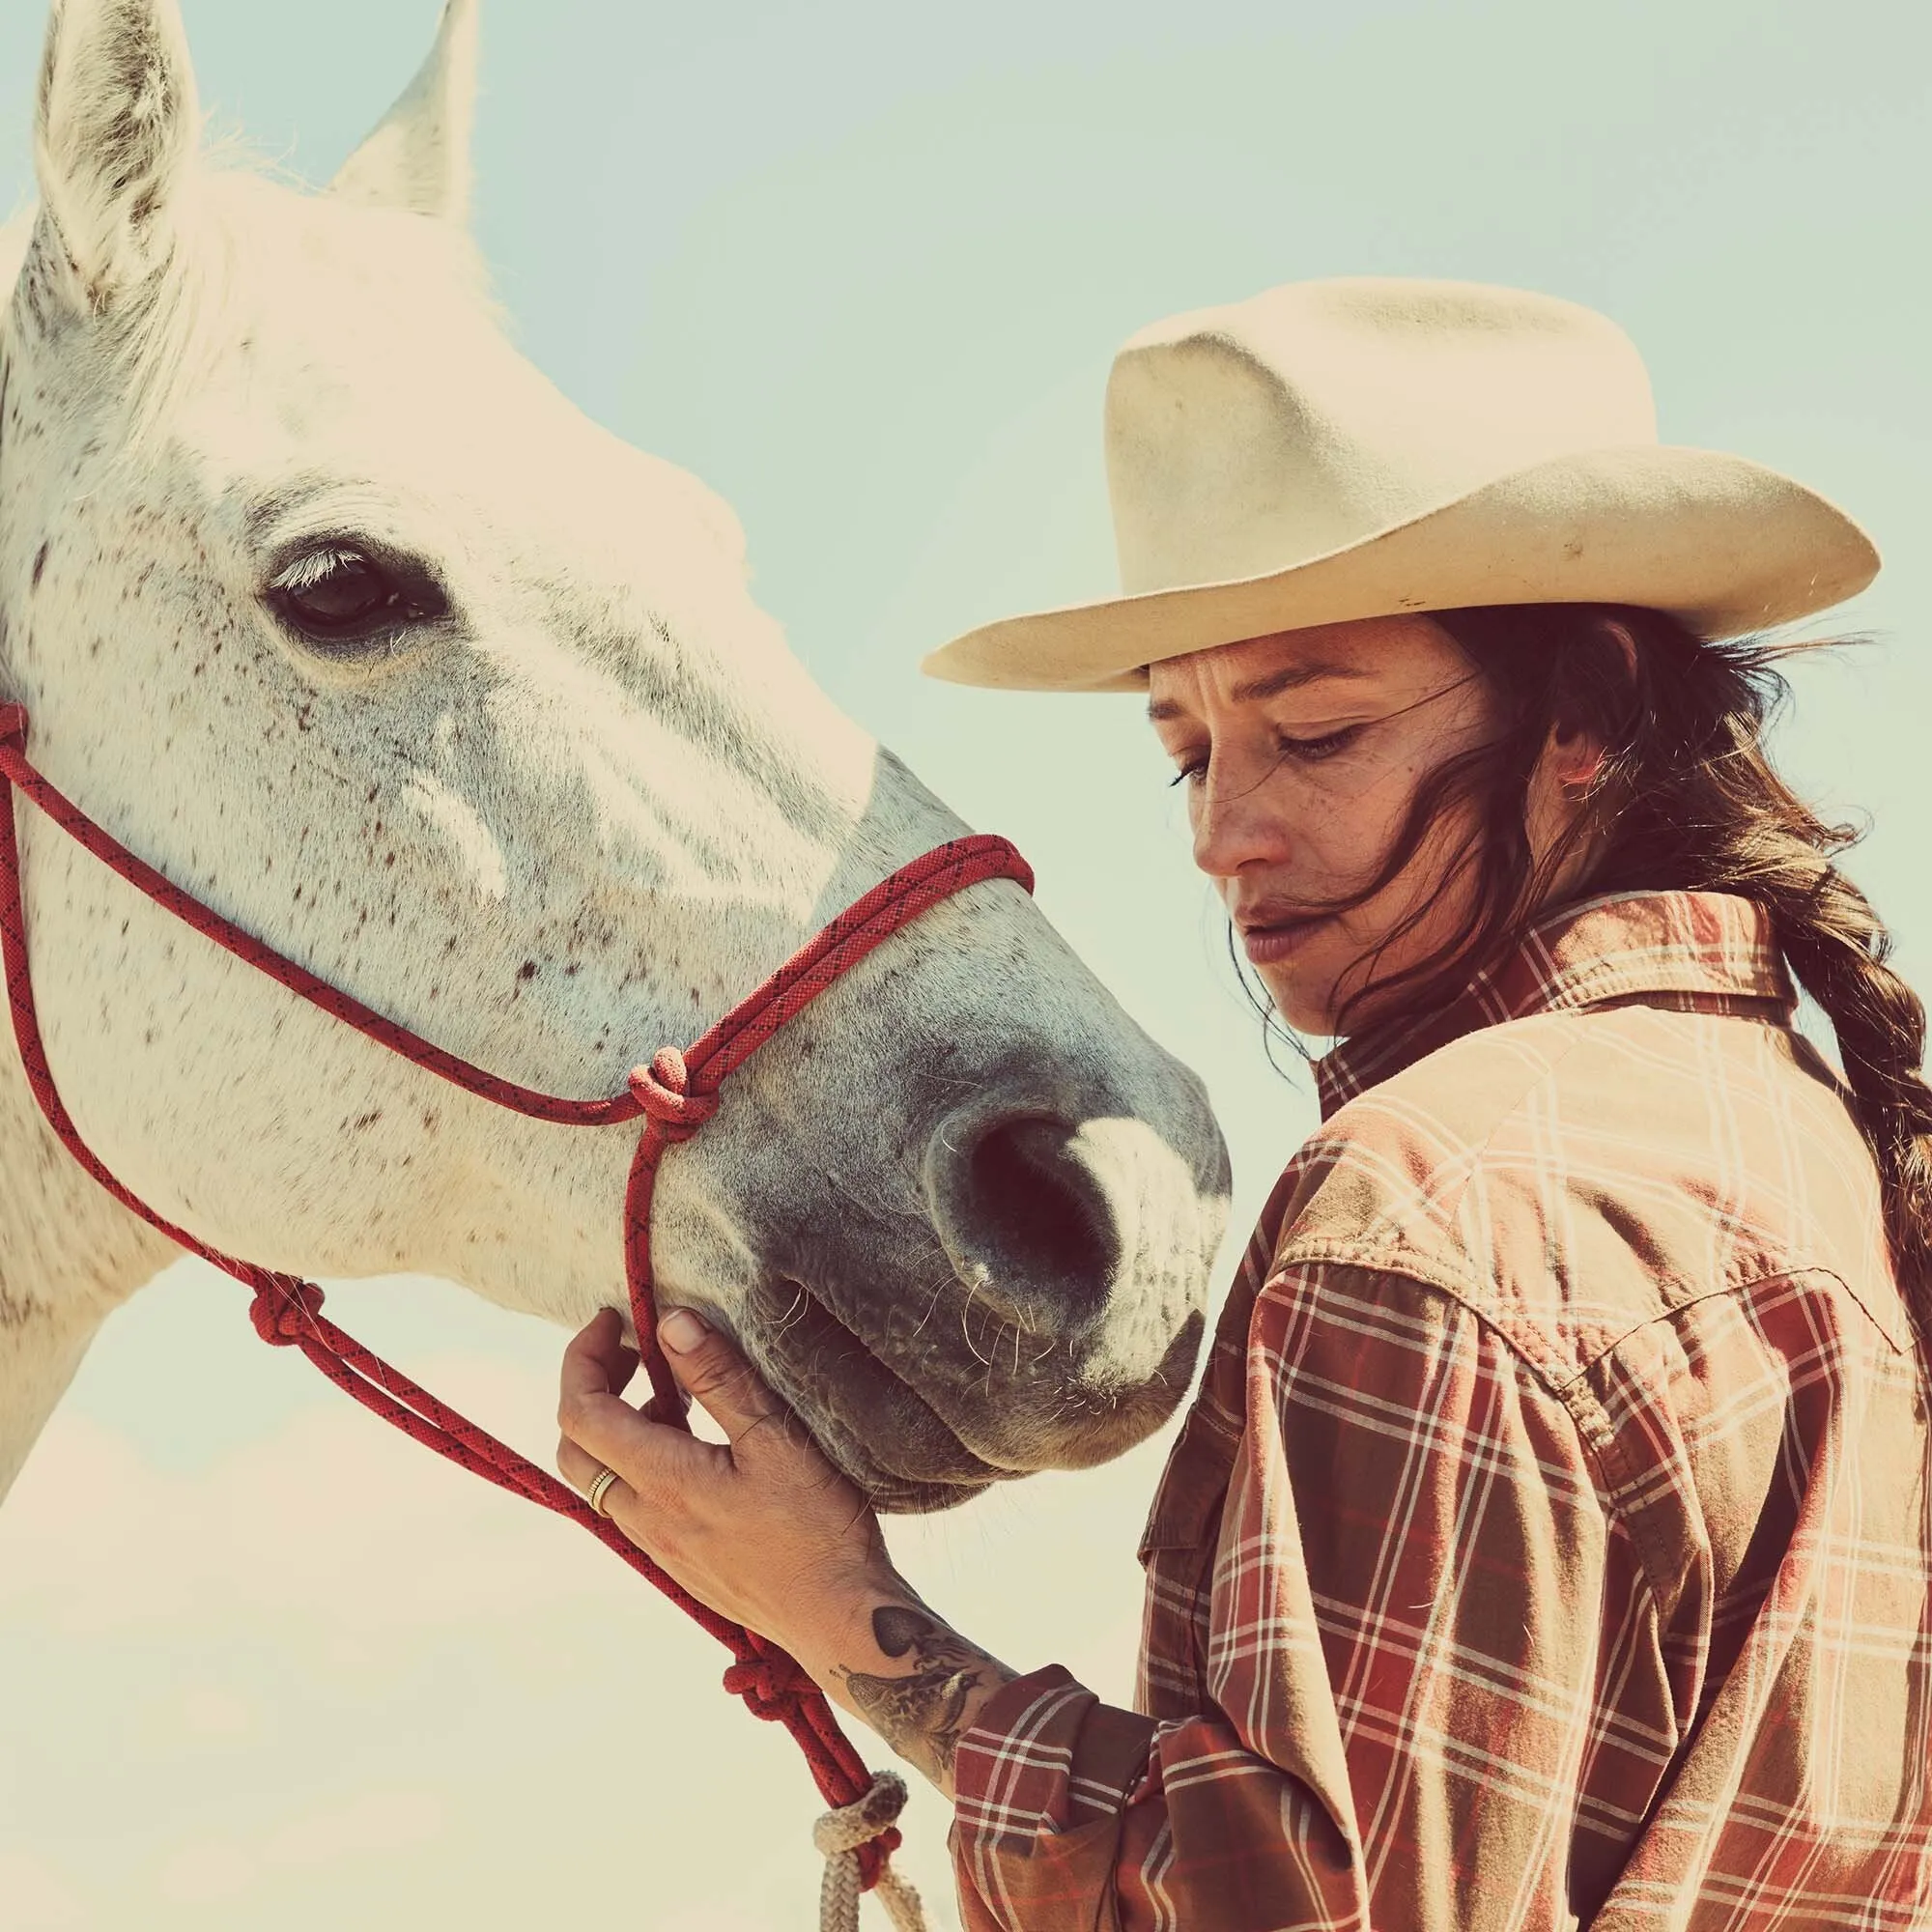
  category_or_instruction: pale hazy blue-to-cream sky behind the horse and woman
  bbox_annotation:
[0,0,1932,1932]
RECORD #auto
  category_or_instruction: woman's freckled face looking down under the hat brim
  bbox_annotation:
[1148,616,1495,1034]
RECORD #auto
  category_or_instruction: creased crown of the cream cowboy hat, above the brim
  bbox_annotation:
[1107,278,1658,595]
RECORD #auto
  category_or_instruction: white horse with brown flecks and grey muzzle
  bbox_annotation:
[0,0,1227,1509]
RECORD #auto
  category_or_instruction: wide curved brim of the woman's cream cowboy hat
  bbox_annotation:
[920,444,1878,692]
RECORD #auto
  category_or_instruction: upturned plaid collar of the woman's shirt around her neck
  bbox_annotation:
[1316,893,1797,1121]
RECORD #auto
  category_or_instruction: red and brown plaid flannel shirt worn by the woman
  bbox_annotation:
[952,893,1932,1932]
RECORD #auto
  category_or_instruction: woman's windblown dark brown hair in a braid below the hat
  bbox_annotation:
[1236,605,1932,1354]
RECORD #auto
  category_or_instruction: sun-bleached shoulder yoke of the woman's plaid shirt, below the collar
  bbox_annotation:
[1275,1003,1911,1393]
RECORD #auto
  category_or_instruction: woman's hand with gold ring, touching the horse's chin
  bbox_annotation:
[556,1308,893,1669]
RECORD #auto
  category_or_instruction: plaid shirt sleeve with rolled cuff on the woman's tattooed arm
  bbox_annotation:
[952,1264,1681,1932]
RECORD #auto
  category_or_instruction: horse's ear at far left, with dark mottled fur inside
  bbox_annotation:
[33,0,201,311]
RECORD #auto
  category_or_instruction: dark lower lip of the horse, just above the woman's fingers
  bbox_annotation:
[740,1275,1024,1515]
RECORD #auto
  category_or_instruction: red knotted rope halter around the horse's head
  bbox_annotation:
[0,705,1034,1888]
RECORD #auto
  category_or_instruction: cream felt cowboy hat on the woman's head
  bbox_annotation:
[923,278,1878,692]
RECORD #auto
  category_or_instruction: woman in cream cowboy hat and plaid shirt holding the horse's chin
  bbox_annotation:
[562,282,1932,1932]
